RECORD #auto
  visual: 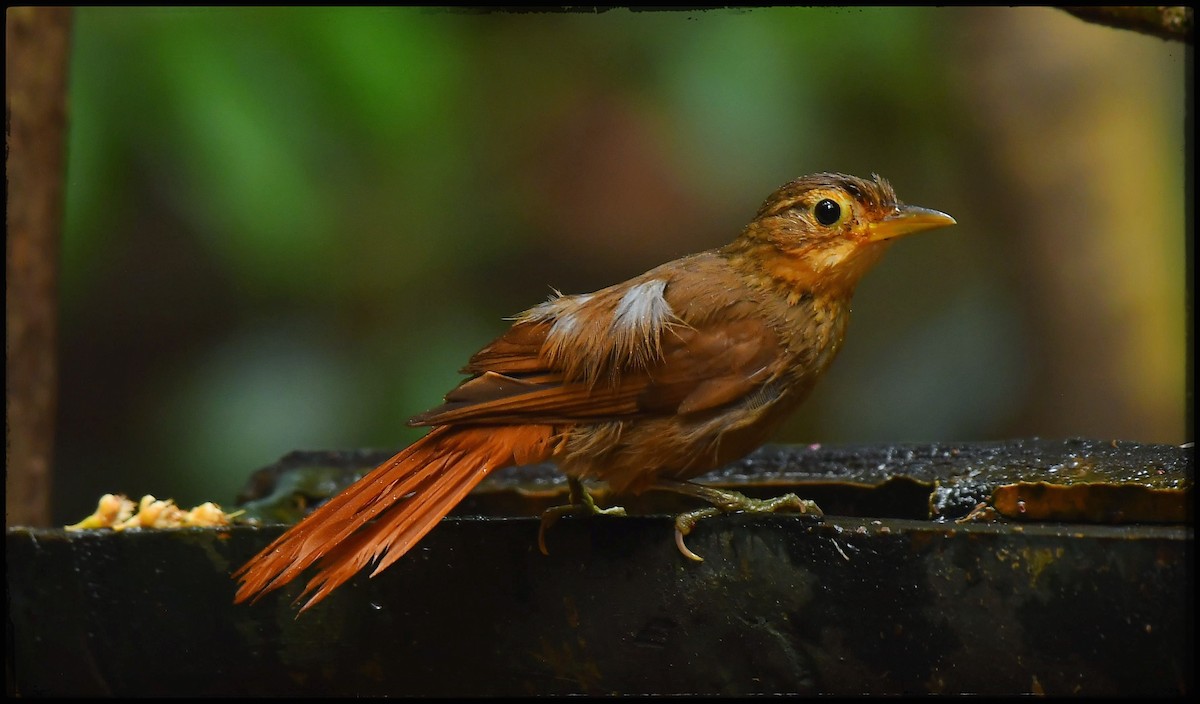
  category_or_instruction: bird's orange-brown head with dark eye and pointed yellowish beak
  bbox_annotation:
[726,173,954,295]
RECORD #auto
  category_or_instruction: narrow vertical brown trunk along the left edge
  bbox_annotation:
[5,7,71,525]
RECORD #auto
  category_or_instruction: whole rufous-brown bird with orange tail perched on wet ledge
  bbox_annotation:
[233,173,956,613]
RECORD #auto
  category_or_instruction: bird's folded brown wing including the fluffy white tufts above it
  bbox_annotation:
[410,267,784,426]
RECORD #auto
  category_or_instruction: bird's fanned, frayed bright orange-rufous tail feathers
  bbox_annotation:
[233,426,554,612]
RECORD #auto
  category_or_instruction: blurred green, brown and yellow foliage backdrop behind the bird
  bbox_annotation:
[54,7,1186,522]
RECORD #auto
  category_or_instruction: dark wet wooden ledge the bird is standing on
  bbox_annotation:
[6,440,1195,697]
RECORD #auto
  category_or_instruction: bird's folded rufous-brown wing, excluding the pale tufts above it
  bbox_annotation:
[409,318,781,426]
